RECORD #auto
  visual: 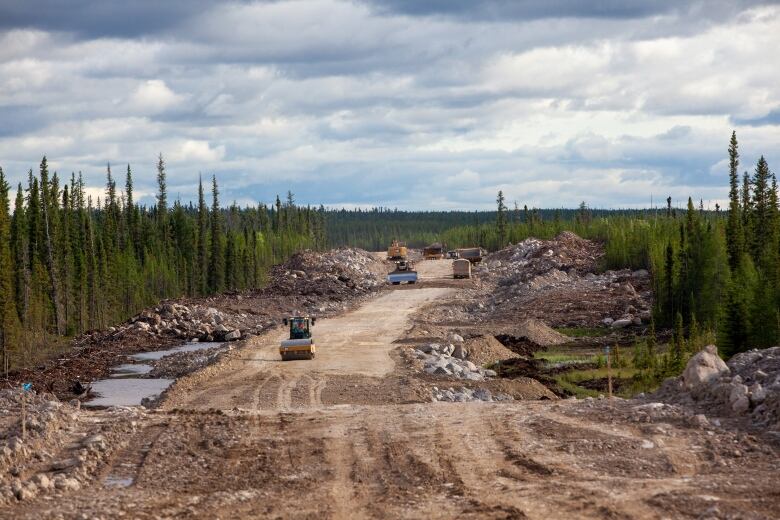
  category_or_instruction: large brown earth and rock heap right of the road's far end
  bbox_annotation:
[471,232,652,329]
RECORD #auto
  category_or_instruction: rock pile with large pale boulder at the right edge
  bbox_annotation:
[650,345,780,435]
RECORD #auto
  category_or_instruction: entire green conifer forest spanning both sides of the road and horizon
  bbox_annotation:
[0,134,780,372]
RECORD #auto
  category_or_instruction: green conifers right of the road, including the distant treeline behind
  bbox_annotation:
[328,134,780,360]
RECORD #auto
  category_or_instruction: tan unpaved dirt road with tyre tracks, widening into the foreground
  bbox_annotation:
[6,261,780,520]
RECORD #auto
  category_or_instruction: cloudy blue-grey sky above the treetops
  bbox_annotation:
[0,0,780,210]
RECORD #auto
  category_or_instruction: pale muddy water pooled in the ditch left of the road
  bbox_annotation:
[84,342,221,407]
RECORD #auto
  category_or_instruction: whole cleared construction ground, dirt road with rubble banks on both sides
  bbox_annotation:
[0,236,780,519]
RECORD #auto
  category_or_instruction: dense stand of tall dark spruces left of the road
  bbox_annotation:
[0,155,325,370]
